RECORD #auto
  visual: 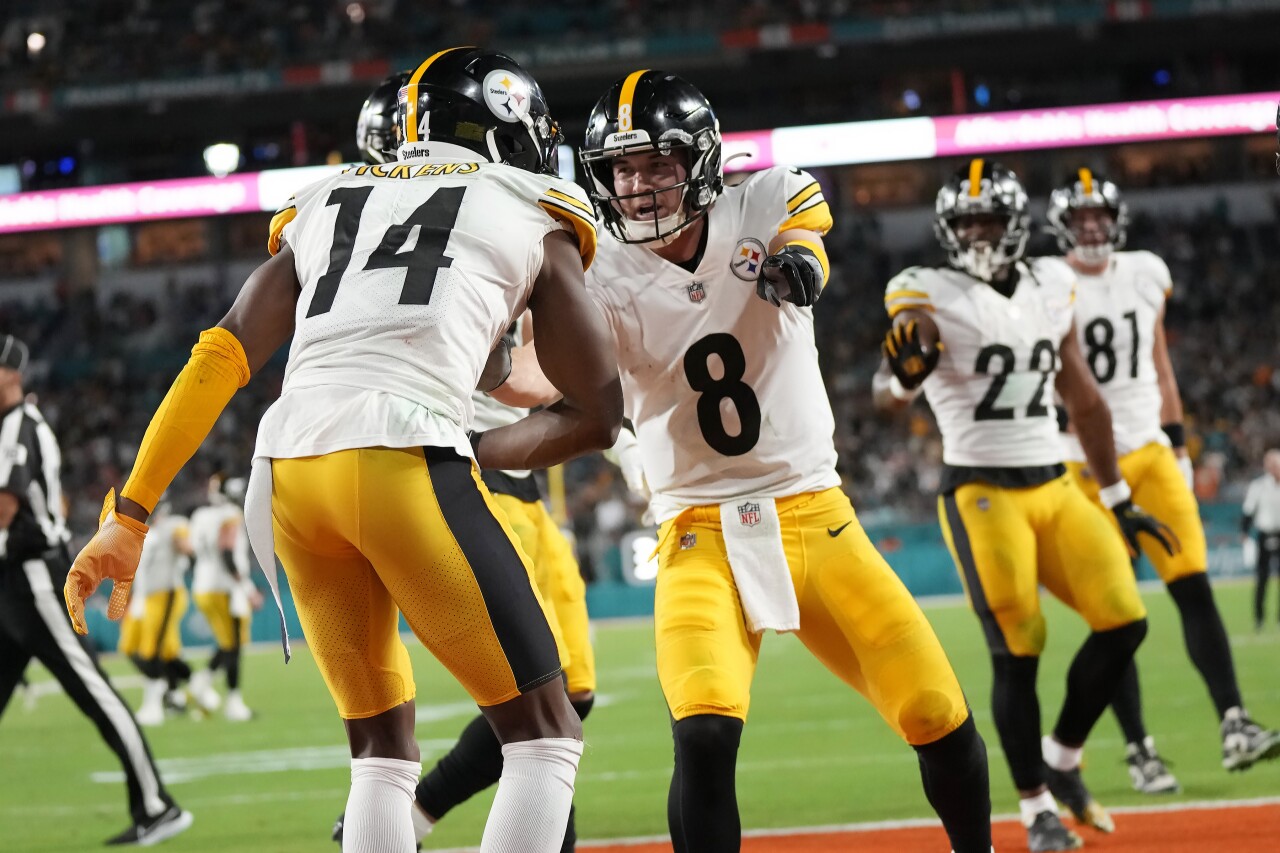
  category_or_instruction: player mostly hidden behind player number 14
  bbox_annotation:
[333,72,595,853]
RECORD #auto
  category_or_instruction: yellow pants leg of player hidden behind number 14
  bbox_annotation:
[493,493,595,693]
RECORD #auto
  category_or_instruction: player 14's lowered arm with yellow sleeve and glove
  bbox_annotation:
[63,246,298,634]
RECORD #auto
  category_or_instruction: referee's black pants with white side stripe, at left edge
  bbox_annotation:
[0,551,173,824]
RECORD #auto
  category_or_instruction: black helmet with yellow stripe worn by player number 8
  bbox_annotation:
[579,70,724,243]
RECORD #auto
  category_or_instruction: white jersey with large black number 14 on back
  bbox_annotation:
[255,160,595,459]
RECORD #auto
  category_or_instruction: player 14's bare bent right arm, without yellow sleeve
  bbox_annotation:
[476,231,622,469]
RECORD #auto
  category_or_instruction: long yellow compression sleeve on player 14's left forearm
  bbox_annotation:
[120,328,248,512]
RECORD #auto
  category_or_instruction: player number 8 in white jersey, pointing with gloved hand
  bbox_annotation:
[496,70,991,853]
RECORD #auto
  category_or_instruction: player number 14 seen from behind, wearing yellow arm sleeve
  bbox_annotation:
[65,47,622,853]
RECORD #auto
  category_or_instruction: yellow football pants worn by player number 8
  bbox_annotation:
[654,488,969,745]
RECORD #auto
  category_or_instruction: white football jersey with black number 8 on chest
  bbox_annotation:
[586,162,840,520]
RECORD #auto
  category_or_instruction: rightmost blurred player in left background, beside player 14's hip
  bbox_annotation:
[191,473,262,722]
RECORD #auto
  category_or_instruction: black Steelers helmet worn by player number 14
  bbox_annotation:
[396,47,563,174]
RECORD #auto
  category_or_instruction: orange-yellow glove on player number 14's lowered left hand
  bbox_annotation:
[63,489,147,634]
